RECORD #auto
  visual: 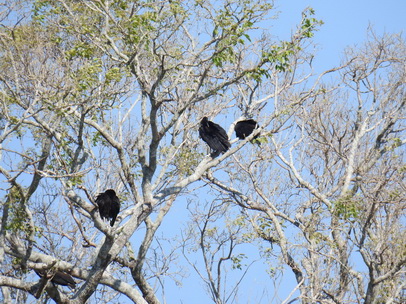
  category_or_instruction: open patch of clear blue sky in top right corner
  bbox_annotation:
[273,0,406,72]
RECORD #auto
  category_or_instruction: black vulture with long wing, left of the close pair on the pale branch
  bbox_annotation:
[199,117,231,158]
